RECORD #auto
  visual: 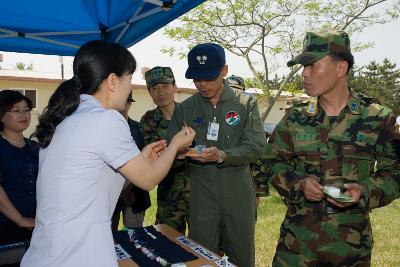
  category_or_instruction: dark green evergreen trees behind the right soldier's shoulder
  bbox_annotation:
[349,59,400,114]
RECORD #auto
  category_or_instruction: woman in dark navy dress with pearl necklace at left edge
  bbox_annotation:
[0,90,39,245]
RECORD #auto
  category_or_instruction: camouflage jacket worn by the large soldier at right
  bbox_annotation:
[269,90,400,209]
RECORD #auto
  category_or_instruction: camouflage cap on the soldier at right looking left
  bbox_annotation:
[287,31,351,67]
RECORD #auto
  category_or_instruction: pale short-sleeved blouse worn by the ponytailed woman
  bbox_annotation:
[21,95,140,267]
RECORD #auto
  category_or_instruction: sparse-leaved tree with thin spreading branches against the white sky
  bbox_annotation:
[163,0,400,119]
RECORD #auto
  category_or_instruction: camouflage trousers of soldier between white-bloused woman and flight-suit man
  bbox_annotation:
[156,172,190,234]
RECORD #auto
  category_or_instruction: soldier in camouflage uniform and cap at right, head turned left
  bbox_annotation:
[270,31,400,266]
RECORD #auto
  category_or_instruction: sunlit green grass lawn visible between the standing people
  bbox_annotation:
[145,190,400,267]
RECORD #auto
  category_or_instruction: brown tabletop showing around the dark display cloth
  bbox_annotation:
[118,224,220,267]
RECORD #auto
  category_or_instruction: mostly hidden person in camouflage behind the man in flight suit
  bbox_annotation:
[226,75,269,208]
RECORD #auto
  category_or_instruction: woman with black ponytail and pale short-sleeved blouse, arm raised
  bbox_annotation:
[21,41,195,267]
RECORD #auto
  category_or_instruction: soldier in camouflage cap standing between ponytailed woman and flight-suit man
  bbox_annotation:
[140,67,189,234]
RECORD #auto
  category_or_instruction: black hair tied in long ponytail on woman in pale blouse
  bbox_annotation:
[33,41,136,148]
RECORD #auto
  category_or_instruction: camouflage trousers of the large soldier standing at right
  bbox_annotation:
[272,205,373,267]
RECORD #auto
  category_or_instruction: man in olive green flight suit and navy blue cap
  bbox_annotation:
[168,43,265,267]
